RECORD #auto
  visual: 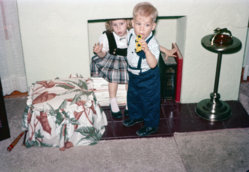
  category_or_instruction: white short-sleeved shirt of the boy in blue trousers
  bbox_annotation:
[127,29,160,75]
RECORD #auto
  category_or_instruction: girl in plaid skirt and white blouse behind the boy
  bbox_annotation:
[91,19,130,119]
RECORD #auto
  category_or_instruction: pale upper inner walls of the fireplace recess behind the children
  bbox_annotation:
[88,16,187,59]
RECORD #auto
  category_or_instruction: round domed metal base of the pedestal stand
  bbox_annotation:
[196,93,231,121]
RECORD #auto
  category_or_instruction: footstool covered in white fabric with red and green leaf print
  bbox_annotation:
[23,77,107,150]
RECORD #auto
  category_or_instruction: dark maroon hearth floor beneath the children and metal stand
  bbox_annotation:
[102,101,249,140]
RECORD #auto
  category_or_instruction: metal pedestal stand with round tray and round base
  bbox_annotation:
[196,35,241,121]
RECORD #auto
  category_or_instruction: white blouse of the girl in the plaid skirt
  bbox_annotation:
[99,31,128,52]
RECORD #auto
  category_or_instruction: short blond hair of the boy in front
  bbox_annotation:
[133,2,158,22]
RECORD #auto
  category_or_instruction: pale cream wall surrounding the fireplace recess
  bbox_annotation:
[17,0,249,103]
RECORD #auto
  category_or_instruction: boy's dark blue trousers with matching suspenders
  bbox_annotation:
[127,34,160,128]
